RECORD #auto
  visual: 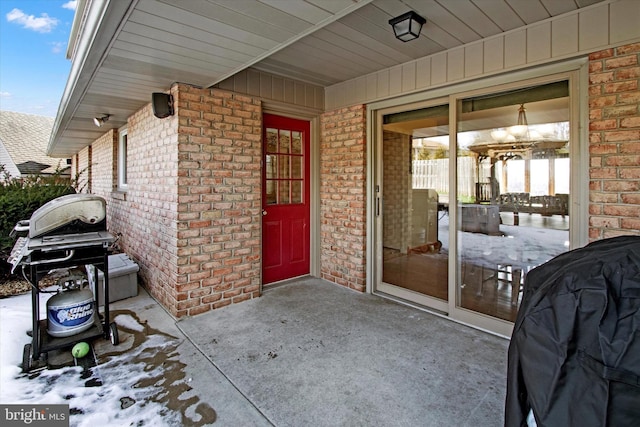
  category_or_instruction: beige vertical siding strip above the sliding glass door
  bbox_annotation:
[325,0,640,110]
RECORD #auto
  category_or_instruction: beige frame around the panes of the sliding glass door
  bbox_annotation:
[367,62,589,337]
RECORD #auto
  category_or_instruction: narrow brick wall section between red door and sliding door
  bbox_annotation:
[320,105,366,291]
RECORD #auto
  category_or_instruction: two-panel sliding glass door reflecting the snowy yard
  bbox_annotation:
[371,73,577,335]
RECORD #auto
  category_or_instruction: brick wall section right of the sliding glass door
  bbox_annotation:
[589,43,640,240]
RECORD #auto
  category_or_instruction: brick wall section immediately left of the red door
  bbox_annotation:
[175,85,262,316]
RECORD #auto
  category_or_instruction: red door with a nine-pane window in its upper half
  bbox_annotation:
[262,114,310,284]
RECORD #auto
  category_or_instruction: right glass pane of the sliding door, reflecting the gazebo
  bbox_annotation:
[456,81,570,321]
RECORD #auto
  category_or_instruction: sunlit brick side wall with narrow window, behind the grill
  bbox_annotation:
[106,98,178,315]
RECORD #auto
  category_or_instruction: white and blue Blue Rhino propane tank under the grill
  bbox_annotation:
[47,276,95,338]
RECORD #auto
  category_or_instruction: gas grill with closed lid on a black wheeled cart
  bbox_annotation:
[7,194,119,372]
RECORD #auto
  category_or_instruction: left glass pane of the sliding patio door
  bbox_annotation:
[381,105,450,310]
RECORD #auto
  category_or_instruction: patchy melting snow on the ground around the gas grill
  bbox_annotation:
[0,294,215,427]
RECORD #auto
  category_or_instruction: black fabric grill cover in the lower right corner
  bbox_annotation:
[505,236,640,427]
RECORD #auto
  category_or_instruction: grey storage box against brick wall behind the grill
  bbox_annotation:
[86,254,140,305]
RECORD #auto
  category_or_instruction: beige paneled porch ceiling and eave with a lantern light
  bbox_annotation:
[48,0,604,157]
